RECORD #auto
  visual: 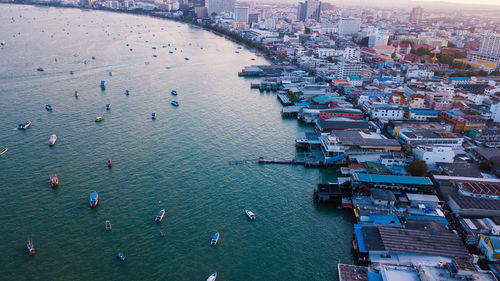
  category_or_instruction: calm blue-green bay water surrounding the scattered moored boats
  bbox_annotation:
[0,5,352,280]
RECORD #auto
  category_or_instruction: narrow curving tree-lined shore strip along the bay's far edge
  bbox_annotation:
[0,2,274,64]
